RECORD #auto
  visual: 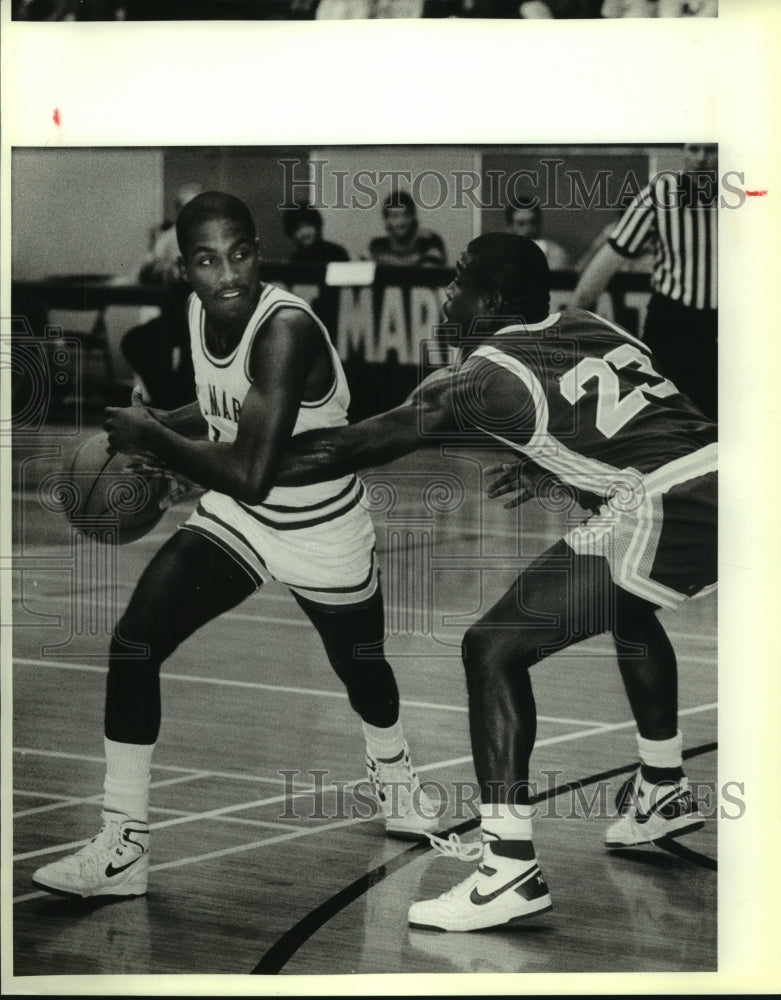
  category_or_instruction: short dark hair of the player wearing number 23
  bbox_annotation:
[464,233,550,323]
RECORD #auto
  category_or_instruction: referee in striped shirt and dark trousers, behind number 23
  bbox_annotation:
[572,145,718,418]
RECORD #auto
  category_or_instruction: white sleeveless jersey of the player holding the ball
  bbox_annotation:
[188,285,362,529]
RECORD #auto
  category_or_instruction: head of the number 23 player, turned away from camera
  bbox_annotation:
[443,233,550,334]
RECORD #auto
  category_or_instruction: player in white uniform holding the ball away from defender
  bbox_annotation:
[33,192,437,897]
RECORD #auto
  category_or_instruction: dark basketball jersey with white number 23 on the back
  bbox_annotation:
[467,309,717,496]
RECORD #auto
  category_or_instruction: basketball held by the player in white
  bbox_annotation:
[57,431,168,545]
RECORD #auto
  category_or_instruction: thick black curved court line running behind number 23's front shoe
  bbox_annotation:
[252,743,717,976]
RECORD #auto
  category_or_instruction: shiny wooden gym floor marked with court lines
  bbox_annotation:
[6,436,717,992]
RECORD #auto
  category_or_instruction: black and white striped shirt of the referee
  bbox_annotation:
[609,171,718,310]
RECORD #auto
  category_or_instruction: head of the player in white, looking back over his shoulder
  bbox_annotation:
[176,191,261,325]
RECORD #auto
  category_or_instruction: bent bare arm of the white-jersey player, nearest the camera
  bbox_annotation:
[103,310,323,504]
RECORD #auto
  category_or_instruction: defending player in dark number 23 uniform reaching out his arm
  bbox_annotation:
[278,233,717,930]
